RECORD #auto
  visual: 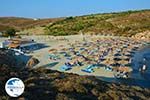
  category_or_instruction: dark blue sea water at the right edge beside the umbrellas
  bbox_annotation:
[120,46,150,88]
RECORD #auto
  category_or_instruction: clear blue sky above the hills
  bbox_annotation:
[0,0,150,18]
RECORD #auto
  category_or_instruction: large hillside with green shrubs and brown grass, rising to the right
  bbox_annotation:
[45,10,150,36]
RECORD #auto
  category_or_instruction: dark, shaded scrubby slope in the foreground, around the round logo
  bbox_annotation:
[0,50,150,100]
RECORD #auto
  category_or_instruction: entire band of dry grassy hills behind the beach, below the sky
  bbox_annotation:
[0,10,150,36]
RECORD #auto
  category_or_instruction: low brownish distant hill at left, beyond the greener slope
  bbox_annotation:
[0,17,62,31]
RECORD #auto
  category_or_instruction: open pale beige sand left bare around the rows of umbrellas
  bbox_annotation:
[0,35,149,81]
